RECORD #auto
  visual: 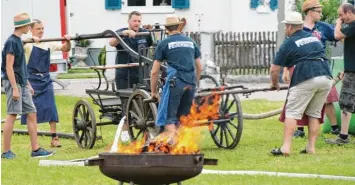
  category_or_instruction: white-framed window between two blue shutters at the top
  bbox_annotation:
[121,0,175,14]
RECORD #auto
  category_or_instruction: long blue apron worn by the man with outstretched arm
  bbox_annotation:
[21,46,59,125]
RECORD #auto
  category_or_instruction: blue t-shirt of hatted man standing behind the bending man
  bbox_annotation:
[303,21,337,48]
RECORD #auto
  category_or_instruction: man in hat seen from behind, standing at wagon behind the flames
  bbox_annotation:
[150,15,202,139]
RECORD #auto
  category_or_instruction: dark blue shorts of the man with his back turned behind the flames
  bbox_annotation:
[166,78,196,124]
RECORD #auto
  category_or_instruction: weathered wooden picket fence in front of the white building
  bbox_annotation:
[213,32,277,75]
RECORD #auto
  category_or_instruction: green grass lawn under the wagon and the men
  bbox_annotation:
[1,95,355,185]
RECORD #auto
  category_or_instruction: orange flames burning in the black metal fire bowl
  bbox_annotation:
[117,94,220,154]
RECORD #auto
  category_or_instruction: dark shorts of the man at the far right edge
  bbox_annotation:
[339,72,355,113]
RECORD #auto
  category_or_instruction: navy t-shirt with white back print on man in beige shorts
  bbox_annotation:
[274,30,332,87]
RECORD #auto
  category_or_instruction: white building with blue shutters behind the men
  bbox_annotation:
[1,0,294,78]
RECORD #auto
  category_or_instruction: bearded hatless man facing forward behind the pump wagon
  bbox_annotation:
[109,11,153,141]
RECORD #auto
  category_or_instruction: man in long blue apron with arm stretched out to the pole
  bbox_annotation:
[21,19,71,147]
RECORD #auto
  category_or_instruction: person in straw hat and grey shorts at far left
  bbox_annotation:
[1,13,54,159]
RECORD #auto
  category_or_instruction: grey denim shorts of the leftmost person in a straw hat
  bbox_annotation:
[3,80,37,115]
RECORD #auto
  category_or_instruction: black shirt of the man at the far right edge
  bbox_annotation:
[340,21,355,72]
